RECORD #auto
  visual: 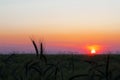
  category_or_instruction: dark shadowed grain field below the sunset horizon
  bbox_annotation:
[0,54,120,80]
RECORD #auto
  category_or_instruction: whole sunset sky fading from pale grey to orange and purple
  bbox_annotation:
[0,0,120,53]
